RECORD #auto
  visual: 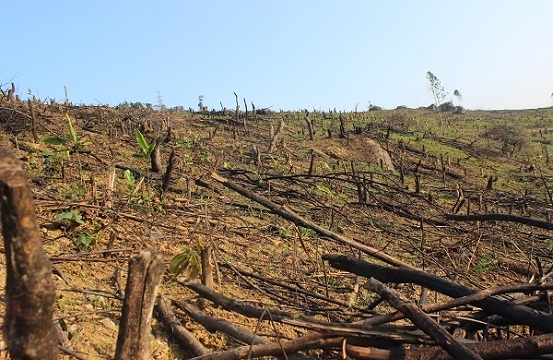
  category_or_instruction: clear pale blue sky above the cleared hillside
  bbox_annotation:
[0,0,553,110]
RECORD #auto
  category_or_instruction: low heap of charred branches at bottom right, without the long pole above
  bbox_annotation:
[159,255,553,360]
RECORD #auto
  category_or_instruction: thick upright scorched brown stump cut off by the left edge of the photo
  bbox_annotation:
[0,149,59,360]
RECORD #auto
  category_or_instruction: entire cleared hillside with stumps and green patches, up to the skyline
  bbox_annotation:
[0,100,553,359]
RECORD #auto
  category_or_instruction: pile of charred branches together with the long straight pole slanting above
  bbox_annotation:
[153,173,553,360]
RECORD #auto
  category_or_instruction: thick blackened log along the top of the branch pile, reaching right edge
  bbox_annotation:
[323,255,553,333]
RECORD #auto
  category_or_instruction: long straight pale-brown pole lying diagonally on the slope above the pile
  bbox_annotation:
[211,172,415,269]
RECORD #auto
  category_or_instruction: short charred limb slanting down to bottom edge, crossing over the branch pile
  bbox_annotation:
[367,278,482,360]
